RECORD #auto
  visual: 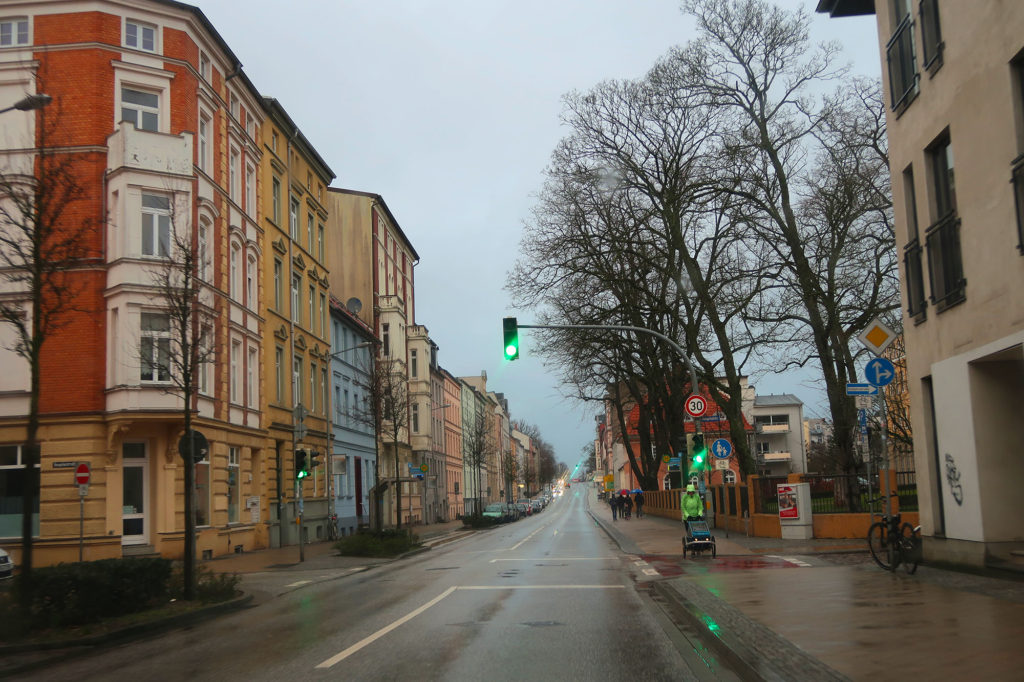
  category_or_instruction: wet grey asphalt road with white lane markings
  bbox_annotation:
[22,492,735,682]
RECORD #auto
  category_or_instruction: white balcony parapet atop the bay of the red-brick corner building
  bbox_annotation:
[106,121,193,175]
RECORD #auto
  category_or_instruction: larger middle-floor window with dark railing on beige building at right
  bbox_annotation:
[925,133,967,312]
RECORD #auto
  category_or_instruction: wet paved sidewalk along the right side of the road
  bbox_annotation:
[588,483,1024,680]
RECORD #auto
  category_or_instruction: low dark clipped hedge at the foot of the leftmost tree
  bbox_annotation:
[11,558,171,630]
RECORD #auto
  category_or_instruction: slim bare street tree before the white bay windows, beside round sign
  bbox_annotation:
[138,202,214,600]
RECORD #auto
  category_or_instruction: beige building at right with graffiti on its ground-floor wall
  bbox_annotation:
[817,0,1024,566]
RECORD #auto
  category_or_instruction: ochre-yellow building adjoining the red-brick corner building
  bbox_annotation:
[260,97,334,547]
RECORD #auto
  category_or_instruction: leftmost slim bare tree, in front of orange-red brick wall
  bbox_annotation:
[0,91,101,597]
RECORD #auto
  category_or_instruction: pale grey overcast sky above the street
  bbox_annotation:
[197,0,880,467]
